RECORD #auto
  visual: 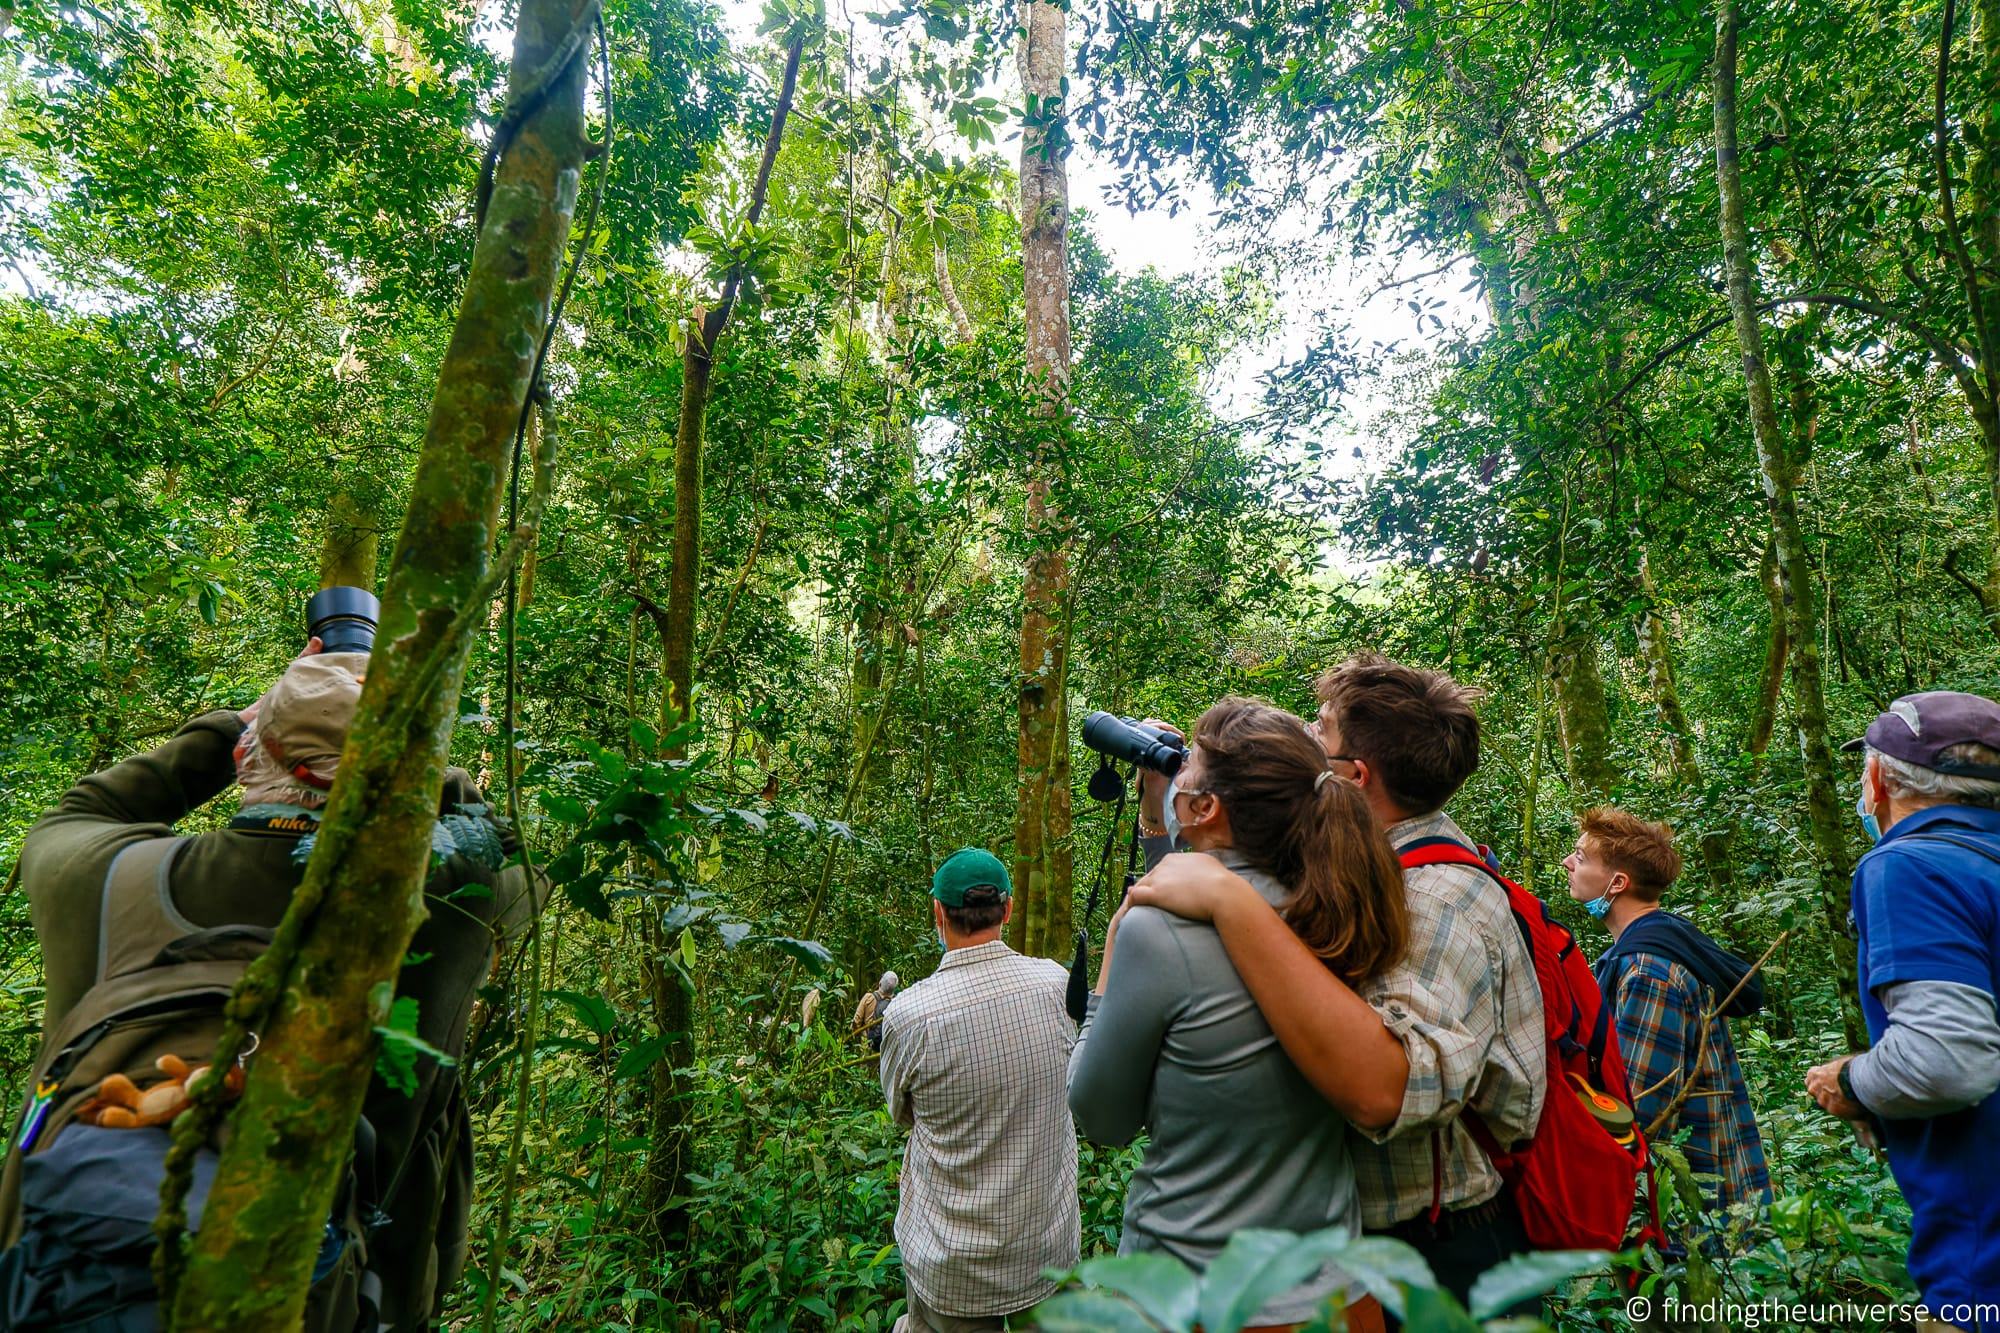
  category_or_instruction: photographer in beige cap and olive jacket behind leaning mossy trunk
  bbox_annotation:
[0,638,536,1333]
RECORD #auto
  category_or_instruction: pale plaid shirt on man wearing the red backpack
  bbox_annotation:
[1352,811,1548,1231]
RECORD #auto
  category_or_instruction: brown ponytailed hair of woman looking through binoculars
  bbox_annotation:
[1194,697,1410,985]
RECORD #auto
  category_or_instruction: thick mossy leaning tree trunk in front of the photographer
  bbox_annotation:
[174,0,588,1333]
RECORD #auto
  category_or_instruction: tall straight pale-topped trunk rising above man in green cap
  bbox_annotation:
[1010,0,1070,959]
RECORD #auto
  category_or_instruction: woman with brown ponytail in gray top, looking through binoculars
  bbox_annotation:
[1070,699,1410,1333]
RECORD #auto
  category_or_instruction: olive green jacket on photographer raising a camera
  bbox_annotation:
[20,711,546,1329]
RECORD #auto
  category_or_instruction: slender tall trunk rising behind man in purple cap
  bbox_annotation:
[1714,0,1866,1051]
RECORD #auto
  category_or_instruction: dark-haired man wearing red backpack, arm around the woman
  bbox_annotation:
[1132,654,1548,1301]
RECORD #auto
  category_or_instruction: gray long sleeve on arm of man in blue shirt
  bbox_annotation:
[1840,980,2000,1121]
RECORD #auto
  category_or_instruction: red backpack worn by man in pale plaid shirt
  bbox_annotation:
[1398,839,1658,1249]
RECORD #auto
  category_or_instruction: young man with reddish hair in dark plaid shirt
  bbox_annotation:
[1562,807,1770,1209]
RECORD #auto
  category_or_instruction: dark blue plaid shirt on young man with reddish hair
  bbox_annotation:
[1606,953,1770,1209]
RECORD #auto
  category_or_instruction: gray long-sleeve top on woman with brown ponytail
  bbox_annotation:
[1070,849,1362,1323]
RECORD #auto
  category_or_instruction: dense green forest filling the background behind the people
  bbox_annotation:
[0,0,2000,1329]
